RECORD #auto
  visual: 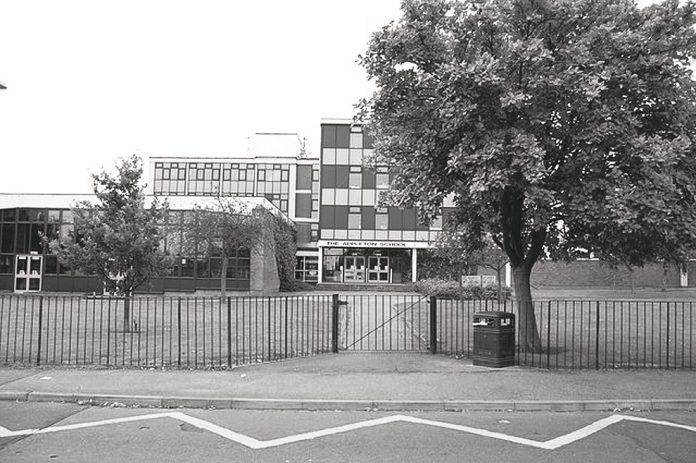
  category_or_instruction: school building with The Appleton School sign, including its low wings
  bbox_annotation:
[0,119,696,293]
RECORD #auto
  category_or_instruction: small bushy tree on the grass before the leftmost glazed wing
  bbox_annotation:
[50,155,171,331]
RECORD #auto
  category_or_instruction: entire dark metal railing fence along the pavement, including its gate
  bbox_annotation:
[0,294,696,369]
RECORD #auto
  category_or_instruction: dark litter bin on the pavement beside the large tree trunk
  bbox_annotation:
[473,312,515,368]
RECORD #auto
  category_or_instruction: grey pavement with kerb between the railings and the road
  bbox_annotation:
[0,352,696,411]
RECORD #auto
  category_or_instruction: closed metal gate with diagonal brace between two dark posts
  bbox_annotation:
[338,294,430,352]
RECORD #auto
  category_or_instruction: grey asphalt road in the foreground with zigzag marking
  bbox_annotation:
[0,402,696,463]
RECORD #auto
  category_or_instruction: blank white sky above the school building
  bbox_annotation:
[0,0,400,193]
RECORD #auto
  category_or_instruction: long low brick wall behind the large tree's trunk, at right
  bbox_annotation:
[532,260,684,288]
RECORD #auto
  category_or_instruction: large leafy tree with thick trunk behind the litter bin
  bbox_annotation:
[359,0,696,350]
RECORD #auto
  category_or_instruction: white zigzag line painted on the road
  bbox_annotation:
[0,412,696,450]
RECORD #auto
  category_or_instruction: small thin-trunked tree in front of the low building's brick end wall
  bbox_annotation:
[184,197,268,300]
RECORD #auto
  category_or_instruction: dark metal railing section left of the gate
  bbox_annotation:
[0,295,332,368]
